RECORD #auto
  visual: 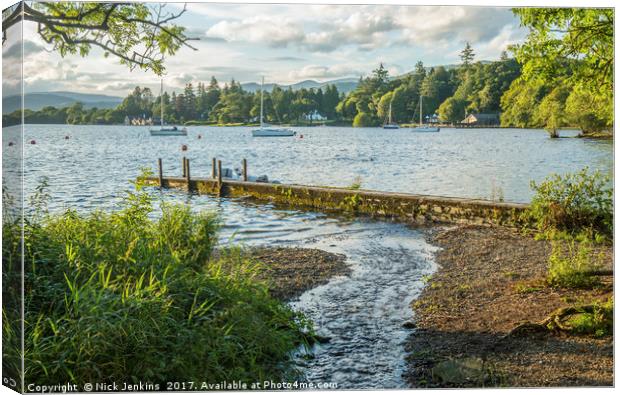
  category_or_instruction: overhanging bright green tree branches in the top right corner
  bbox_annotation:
[513,8,614,133]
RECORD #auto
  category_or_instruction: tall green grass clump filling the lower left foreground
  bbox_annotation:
[5,176,311,384]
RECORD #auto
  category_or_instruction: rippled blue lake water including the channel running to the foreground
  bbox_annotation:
[2,125,613,389]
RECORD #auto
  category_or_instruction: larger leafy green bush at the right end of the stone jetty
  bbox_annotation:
[528,168,613,239]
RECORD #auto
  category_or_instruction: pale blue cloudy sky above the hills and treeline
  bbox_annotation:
[3,3,527,96]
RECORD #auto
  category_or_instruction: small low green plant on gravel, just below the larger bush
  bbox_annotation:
[547,242,602,288]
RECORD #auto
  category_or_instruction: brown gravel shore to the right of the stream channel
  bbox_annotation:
[406,226,613,387]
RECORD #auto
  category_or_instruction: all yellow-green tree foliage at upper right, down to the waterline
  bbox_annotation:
[502,8,614,134]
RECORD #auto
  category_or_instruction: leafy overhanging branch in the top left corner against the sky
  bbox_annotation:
[2,2,196,75]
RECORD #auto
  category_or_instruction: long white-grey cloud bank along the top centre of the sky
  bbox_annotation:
[205,5,518,53]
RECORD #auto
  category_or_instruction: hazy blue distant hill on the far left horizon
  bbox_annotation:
[2,92,123,114]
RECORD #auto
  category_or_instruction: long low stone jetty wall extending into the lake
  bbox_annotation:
[145,172,528,226]
